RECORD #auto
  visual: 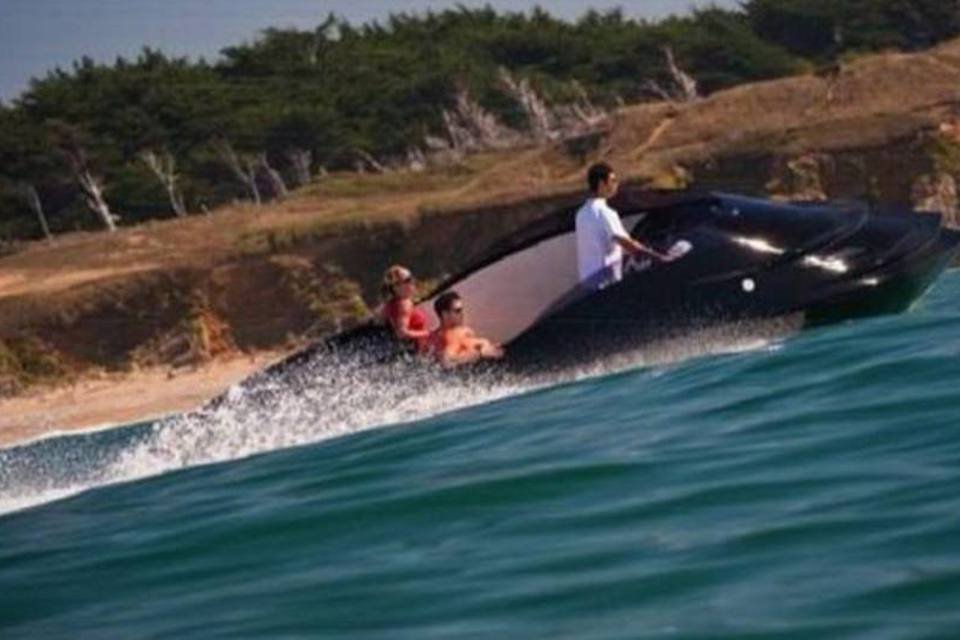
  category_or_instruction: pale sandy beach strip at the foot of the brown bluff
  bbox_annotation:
[0,351,286,449]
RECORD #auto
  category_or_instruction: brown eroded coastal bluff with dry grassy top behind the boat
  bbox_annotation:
[0,42,960,394]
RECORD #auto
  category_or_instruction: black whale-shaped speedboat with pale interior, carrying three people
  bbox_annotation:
[251,191,960,374]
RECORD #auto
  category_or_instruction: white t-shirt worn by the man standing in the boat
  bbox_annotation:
[577,198,630,283]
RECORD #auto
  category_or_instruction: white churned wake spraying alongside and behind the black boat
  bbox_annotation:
[0,318,802,515]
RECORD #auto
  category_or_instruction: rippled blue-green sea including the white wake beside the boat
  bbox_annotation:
[0,272,960,640]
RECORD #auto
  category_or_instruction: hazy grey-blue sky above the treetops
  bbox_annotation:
[0,0,737,101]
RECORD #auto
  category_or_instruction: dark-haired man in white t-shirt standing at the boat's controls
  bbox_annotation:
[577,162,673,291]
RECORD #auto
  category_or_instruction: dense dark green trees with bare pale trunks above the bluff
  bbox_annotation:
[0,0,960,240]
